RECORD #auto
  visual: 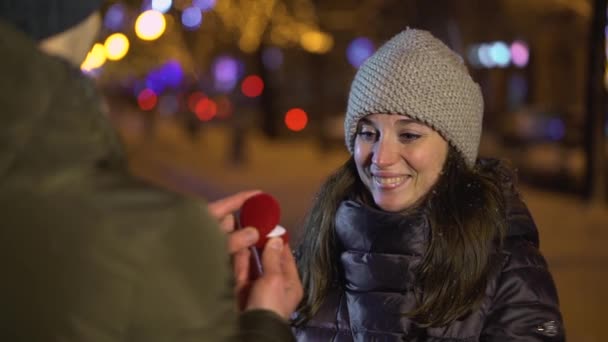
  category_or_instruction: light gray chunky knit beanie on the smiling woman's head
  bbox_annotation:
[344,28,483,167]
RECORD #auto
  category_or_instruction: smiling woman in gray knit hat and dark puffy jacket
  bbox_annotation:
[295,29,564,341]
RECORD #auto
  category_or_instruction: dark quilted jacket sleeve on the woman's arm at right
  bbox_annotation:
[480,239,565,342]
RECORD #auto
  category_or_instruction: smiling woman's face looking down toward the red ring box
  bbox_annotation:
[354,114,448,212]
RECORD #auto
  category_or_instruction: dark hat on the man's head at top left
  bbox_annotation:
[0,0,103,40]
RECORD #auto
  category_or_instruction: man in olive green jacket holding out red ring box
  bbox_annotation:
[0,0,302,342]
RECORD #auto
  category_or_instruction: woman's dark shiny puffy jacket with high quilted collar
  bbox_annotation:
[295,188,565,342]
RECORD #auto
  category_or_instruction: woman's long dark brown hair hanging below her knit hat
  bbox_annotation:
[295,147,506,327]
